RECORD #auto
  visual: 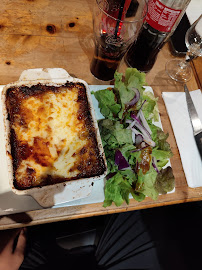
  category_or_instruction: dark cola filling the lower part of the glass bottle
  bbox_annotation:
[125,24,166,72]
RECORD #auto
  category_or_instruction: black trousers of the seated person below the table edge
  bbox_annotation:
[20,203,202,270]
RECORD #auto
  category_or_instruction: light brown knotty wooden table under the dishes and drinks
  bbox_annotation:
[0,0,202,229]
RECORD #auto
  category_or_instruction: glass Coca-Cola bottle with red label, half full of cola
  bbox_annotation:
[125,0,191,72]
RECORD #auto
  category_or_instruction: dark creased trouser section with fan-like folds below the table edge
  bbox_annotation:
[96,211,161,270]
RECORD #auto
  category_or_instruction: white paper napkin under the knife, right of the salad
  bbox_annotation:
[162,90,202,188]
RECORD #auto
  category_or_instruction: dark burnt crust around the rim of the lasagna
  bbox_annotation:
[6,81,106,190]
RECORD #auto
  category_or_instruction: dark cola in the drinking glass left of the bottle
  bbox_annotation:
[90,35,125,81]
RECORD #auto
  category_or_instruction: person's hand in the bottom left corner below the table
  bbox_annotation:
[0,229,26,270]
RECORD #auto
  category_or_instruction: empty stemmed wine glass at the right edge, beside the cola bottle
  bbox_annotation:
[166,14,202,83]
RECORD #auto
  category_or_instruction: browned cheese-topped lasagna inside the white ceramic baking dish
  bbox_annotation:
[6,82,106,190]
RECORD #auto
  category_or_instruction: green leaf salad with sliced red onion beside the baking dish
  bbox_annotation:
[93,68,175,207]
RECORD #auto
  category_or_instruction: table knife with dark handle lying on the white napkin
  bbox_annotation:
[184,84,202,158]
